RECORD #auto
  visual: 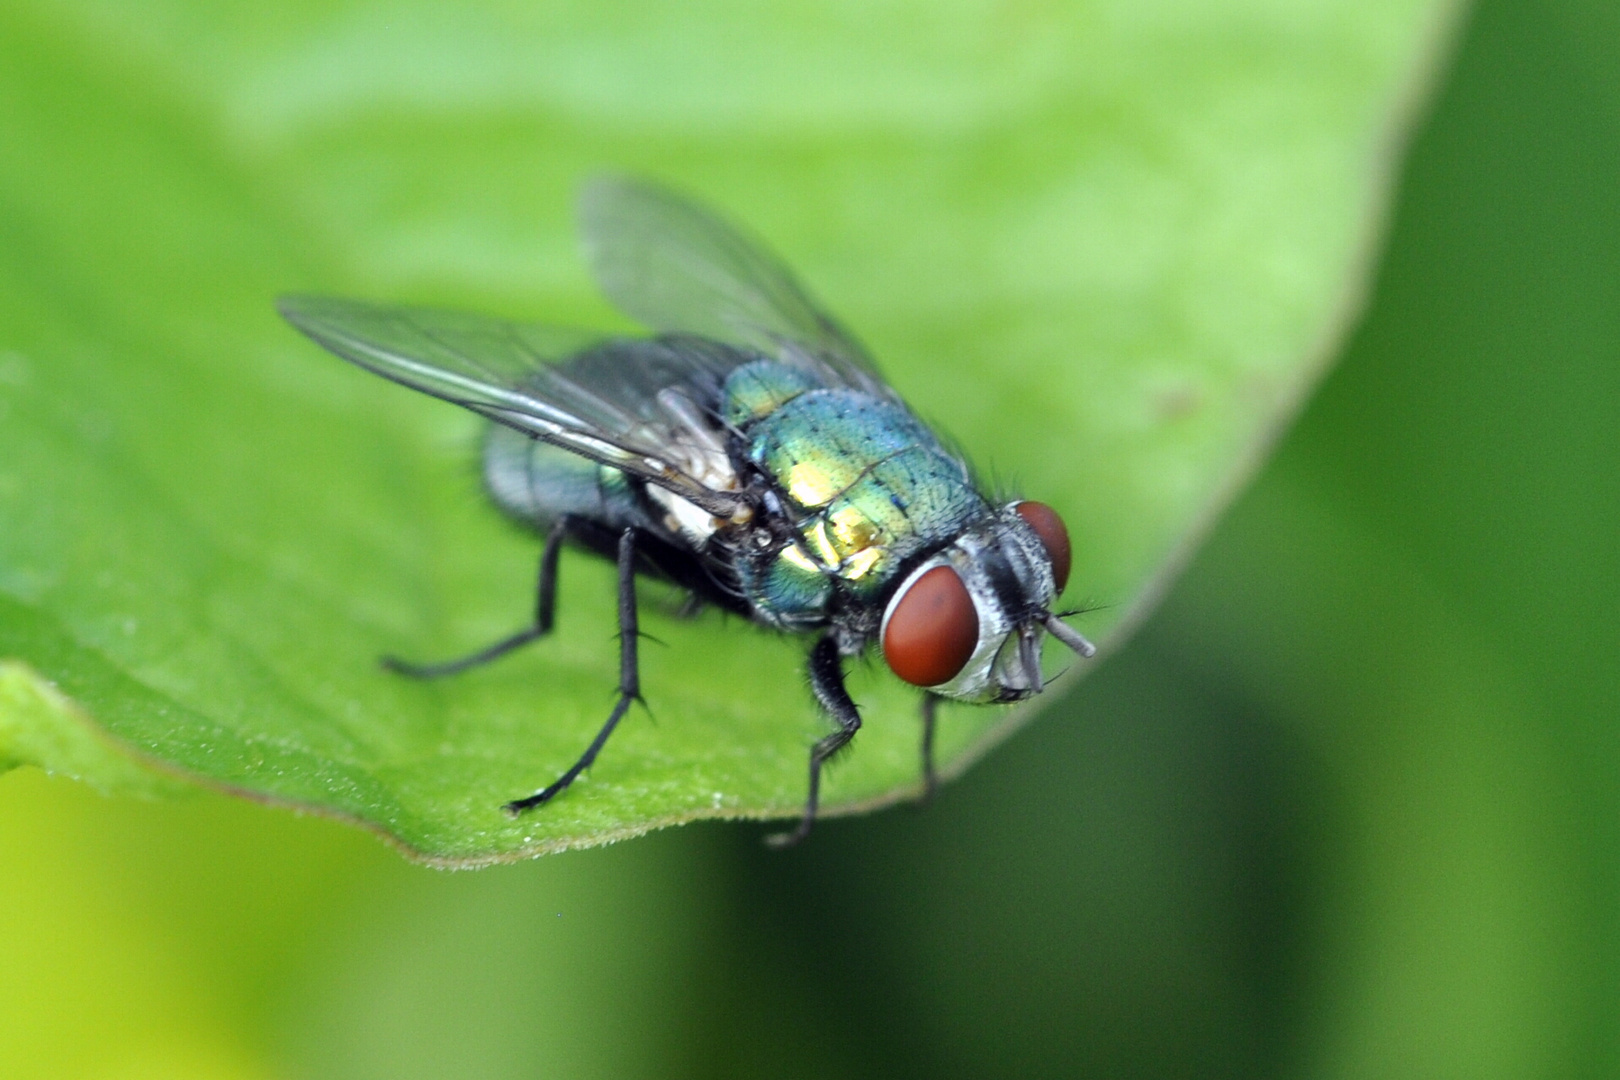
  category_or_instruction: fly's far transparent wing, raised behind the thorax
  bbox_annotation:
[580,176,899,402]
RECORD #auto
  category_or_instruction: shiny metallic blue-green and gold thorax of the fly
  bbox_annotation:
[723,361,990,622]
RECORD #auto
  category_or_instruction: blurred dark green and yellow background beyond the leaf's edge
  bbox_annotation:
[0,0,1620,1080]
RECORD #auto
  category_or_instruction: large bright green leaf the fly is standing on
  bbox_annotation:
[0,0,1453,865]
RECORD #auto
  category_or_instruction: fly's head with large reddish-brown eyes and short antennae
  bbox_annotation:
[880,502,1095,703]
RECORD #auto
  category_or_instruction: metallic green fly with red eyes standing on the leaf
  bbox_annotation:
[279,178,1095,844]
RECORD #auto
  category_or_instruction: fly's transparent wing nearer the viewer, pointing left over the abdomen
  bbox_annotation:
[277,296,745,517]
